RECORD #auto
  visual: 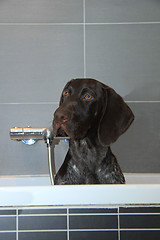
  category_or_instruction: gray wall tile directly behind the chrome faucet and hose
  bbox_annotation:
[0,104,66,175]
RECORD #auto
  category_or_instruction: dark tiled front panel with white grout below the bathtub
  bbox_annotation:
[0,206,160,240]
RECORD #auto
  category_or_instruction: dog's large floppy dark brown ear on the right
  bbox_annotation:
[98,85,134,146]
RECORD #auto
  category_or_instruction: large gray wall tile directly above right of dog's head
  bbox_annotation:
[86,24,160,100]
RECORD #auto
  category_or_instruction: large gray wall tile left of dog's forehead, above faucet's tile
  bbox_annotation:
[0,26,83,102]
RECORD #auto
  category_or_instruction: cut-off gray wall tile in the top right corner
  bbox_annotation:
[86,0,160,23]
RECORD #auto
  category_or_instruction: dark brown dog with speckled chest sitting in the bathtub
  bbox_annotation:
[53,78,134,185]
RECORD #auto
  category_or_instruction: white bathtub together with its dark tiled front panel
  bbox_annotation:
[0,174,160,240]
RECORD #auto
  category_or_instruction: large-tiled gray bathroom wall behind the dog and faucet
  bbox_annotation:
[0,0,160,175]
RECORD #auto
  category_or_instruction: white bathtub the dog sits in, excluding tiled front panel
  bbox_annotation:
[0,174,160,207]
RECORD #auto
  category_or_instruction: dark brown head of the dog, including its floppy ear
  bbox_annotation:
[53,79,134,146]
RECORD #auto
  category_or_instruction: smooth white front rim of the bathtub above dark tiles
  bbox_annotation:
[0,184,160,207]
